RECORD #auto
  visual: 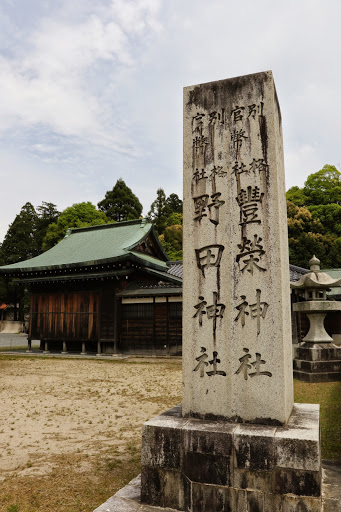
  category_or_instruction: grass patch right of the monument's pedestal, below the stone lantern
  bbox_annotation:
[294,379,341,460]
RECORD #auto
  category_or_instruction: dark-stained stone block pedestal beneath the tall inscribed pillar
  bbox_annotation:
[141,404,321,512]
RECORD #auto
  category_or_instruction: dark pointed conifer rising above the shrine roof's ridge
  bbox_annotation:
[97,178,142,222]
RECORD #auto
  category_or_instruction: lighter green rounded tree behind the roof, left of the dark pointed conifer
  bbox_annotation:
[43,201,111,251]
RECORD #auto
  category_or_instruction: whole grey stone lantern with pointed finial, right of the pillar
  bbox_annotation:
[290,256,341,382]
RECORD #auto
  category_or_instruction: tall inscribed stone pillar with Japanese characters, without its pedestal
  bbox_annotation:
[182,71,293,425]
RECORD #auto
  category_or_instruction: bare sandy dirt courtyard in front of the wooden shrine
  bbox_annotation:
[0,355,181,512]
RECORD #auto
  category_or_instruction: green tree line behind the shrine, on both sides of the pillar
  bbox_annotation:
[0,165,341,310]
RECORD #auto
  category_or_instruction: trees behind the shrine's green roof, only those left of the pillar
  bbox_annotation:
[0,178,182,308]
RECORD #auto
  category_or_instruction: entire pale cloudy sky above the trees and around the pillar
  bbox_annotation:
[0,0,341,242]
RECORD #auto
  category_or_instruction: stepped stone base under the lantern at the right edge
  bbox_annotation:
[294,343,341,382]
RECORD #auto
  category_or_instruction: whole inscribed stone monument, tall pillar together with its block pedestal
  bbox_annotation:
[94,72,322,512]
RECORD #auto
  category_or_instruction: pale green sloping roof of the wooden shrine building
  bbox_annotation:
[0,219,168,274]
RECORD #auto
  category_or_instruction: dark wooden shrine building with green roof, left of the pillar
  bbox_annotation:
[0,219,182,355]
